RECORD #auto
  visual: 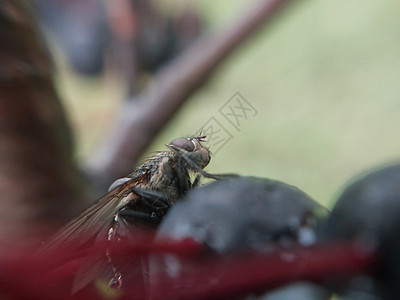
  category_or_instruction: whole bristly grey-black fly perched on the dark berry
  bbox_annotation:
[44,136,224,290]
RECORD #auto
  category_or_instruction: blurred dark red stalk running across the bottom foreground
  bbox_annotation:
[0,238,375,299]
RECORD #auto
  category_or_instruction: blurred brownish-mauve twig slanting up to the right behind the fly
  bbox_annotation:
[86,0,291,185]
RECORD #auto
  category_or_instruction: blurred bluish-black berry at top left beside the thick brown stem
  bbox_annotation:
[32,0,110,75]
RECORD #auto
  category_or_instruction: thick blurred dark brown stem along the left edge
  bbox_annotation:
[0,0,86,244]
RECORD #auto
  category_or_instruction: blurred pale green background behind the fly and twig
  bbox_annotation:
[56,0,400,206]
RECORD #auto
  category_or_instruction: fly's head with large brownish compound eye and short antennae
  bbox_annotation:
[168,136,210,169]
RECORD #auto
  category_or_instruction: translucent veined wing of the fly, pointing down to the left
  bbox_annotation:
[42,174,145,250]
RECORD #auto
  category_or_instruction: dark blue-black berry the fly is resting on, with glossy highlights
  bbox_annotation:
[158,177,328,253]
